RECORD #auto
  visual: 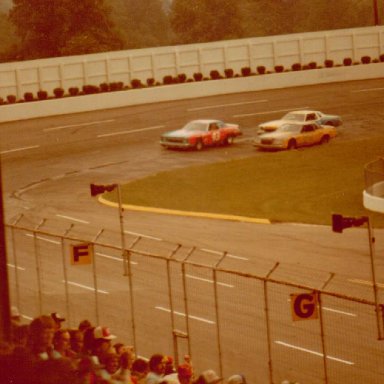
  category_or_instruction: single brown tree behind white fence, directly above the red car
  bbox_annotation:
[170,0,243,44]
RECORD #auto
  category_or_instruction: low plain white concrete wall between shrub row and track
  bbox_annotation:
[0,63,384,123]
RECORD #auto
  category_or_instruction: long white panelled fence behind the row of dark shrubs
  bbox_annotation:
[0,26,384,99]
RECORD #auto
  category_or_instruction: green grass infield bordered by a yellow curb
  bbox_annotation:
[105,136,384,227]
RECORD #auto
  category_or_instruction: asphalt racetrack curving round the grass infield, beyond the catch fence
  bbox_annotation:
[0,79,384,383]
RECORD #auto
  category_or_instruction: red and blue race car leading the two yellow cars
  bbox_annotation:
[160,120,242,151]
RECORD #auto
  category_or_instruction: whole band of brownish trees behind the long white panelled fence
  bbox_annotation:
[0,0,384,62]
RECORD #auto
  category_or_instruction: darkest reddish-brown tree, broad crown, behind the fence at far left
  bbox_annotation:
[9,0,122,59]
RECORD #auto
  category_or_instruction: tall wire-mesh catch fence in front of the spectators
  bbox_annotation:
[6,217,384,384]
